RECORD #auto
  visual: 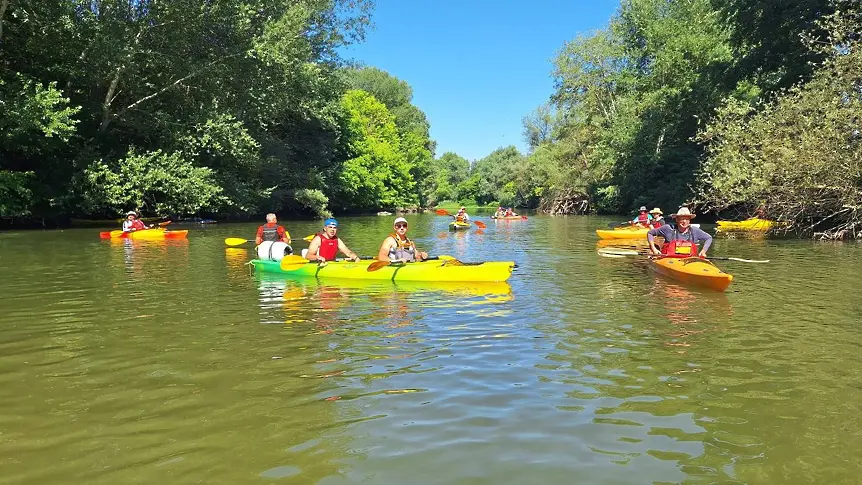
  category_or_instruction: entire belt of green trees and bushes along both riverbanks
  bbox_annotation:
[0,0,862,238]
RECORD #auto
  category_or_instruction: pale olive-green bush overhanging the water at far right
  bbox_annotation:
[698,5,862,238]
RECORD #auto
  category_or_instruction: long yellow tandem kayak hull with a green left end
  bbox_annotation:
[251,256,515,282]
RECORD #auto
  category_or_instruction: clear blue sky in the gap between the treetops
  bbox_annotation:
[343,0,619,160]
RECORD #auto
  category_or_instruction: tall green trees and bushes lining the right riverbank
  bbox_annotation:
[512,0,862,237]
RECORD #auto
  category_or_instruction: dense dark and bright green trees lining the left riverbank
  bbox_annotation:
[0,0,434,222]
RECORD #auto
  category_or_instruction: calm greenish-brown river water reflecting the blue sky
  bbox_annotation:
[0,215,862,485]
